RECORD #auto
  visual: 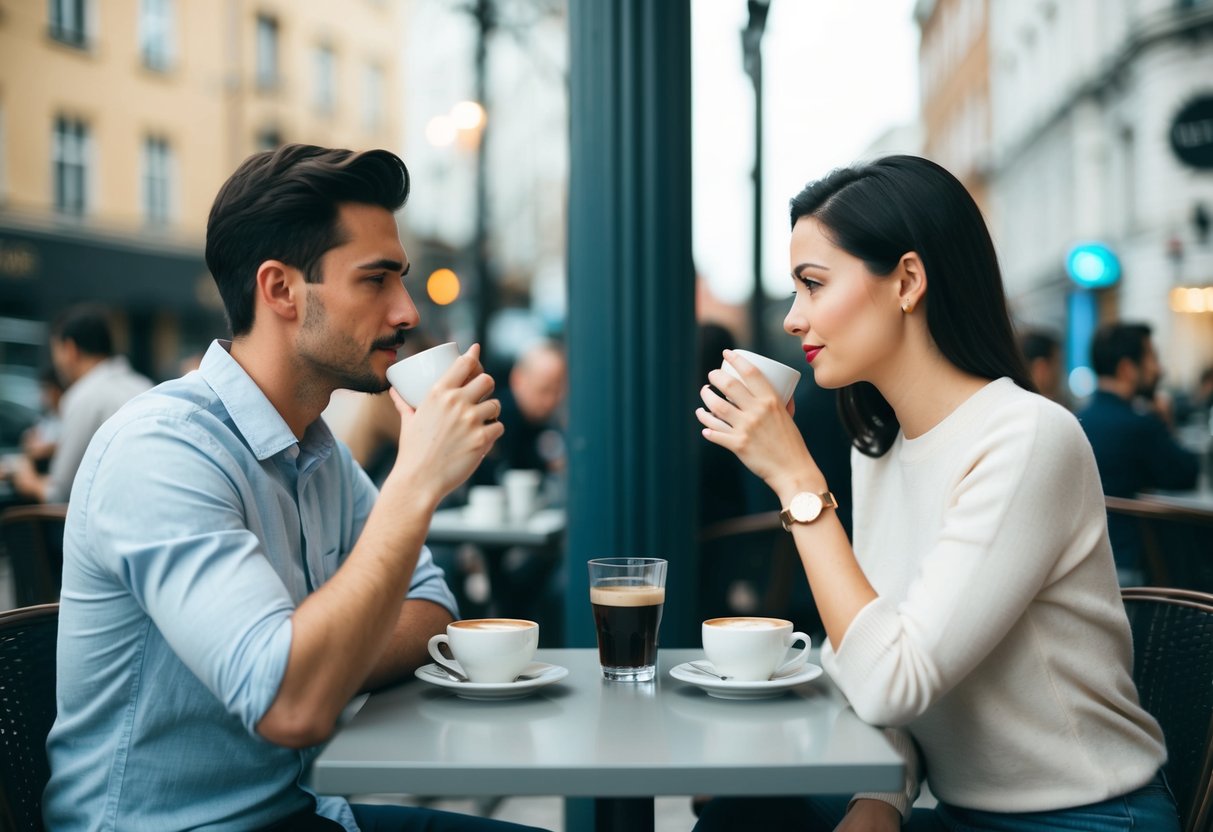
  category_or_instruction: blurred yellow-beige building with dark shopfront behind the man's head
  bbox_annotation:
[0,0,404,376]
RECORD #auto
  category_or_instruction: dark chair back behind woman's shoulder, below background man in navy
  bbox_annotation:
[1104,497,1213,592]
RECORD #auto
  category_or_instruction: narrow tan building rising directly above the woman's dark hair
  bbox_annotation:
[915,0,990,216]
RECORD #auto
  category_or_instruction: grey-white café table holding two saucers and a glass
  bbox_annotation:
[309,649,904,832]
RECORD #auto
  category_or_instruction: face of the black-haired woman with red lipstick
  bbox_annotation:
[784,217,902,388]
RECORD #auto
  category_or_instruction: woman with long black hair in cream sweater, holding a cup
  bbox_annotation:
[696,156,1179,831]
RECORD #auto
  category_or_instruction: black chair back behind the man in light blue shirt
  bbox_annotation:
[0,604,59,831]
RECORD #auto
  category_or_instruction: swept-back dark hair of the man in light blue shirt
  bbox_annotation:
[206,144,409,336]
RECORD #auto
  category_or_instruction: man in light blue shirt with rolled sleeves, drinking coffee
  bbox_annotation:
[44,144,543,832]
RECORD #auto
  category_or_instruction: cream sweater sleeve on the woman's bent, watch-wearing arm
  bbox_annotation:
[824,408,1101,725]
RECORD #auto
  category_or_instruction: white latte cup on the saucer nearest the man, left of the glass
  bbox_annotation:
[428,619,539,684]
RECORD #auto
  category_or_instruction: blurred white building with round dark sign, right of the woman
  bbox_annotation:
[990,0,1213,384]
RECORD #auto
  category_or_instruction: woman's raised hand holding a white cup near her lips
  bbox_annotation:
[695,349,826,501]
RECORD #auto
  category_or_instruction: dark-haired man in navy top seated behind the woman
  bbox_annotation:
[1078,323,1200,586]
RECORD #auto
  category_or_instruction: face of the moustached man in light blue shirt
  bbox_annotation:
[296,203,420,393]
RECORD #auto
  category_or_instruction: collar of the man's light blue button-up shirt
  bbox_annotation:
[199,340,334,460]
